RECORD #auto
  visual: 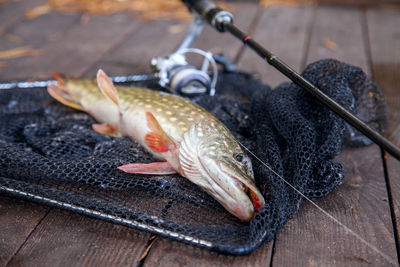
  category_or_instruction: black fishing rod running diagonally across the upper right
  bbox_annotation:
[182,0,400,160]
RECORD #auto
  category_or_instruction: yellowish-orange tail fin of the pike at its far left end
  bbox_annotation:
[47,72,83,110]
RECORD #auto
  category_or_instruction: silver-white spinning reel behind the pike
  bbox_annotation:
[151,16,235,97]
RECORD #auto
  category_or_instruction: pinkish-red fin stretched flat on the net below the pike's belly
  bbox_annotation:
[118,162,176,175]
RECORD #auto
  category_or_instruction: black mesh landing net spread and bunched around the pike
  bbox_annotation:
[0,59,386,254]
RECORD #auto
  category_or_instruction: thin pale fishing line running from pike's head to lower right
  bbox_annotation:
[235,140,397,266]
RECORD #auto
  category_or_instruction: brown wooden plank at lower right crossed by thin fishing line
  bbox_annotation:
[273,148,397,266]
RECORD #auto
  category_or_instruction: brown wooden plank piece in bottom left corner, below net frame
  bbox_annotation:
[0,196,49,266]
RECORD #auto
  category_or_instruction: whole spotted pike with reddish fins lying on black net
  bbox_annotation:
[47,70,264,221]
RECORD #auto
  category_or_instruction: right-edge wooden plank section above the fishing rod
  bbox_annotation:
[367,10,400,145]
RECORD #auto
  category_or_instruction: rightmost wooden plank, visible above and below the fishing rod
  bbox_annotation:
[366,10,400,258]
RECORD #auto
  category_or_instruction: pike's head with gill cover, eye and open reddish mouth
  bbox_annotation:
[180,120,265,221]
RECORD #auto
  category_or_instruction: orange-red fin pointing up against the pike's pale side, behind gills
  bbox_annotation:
[144,112,176,153]
